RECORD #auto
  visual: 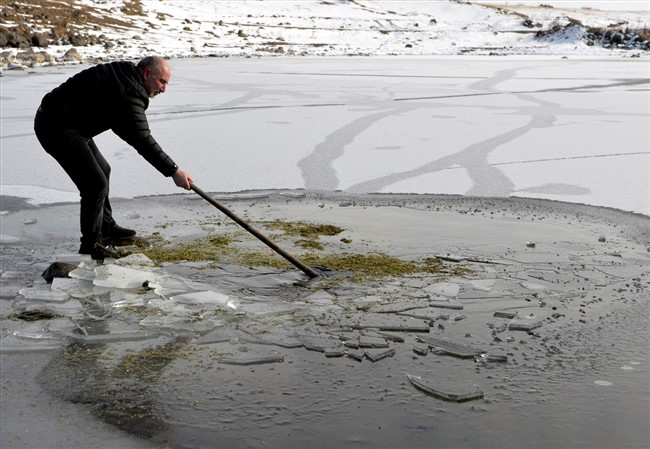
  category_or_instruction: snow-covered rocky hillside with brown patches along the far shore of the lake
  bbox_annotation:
[0,0,650,67]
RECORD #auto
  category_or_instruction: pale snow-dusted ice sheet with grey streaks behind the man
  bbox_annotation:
[0,57,650,215]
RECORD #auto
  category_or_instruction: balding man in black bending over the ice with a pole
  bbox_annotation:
[34,56,192,260]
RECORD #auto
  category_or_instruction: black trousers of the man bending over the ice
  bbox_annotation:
[34,108,115,247]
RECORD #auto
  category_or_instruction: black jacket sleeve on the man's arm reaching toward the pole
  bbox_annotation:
[112,97,178,176]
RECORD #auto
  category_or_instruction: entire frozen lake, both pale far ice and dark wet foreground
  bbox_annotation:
[0,57,650,449]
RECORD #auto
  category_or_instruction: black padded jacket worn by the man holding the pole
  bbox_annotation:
[41,62,178,176]
